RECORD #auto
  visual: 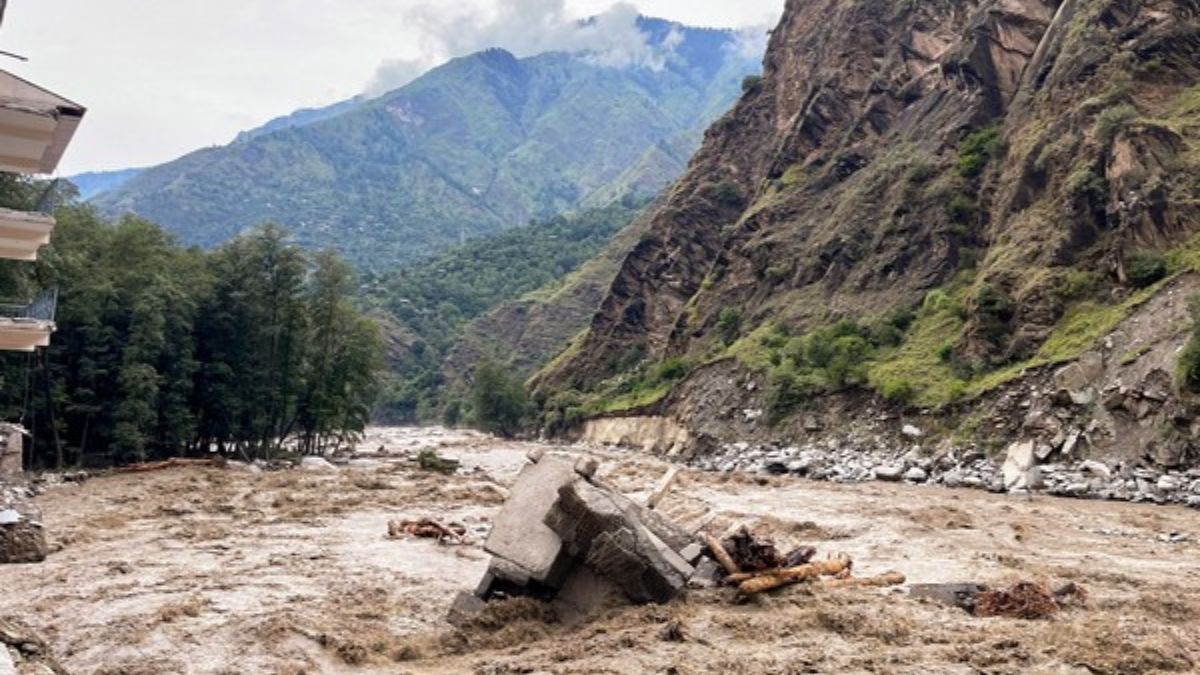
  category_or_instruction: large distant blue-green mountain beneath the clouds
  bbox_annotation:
[95,19,760,267]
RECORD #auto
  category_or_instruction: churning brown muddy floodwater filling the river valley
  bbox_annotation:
[0,429,1200,675]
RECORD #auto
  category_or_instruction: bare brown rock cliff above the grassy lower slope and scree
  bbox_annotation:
[535,0,1200,456]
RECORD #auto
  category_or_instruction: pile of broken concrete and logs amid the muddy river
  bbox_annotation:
[450,452,904,622]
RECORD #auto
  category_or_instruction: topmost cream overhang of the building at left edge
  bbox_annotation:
[0,71,86,173]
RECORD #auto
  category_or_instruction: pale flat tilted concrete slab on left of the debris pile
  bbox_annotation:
[484,454,578,585]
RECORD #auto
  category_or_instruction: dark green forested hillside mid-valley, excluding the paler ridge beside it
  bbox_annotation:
[367,199,642,422]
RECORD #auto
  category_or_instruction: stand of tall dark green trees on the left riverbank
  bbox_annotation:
[0,175,382,467]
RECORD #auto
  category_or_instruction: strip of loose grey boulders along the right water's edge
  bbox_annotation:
[689,426,1200,508]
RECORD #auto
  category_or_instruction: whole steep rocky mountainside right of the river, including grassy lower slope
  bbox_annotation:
[534,0,1200,466]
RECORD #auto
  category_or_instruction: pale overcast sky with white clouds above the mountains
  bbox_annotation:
[0,0,784,175]
